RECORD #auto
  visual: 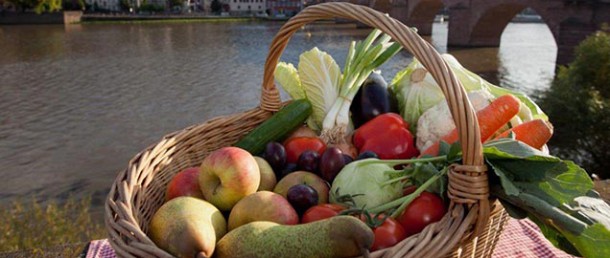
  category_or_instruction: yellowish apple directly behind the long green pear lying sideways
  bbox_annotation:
[228,191,299,231]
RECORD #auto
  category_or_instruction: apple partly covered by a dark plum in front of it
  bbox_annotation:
[273,171,329,204]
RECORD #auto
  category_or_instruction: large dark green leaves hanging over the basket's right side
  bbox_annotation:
[484,139,610,257]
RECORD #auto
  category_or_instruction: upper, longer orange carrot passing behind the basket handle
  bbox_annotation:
[420,94,520,157]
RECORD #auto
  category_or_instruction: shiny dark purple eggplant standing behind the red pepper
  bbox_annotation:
[350,73,397,128]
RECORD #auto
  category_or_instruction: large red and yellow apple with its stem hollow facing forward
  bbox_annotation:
[199,147,261,211]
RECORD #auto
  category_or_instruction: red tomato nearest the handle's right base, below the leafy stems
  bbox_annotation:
[398,192,447,236]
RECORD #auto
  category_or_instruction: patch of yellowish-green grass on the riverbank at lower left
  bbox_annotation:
[0,197,106,256]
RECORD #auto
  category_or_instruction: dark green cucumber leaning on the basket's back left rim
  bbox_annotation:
[234,99,312,155]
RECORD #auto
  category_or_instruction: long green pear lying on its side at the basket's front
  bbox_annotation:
[214,215,374,258]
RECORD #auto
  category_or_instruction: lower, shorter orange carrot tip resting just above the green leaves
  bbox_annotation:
[495,119,553,149]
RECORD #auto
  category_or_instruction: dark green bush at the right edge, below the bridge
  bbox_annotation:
[540,28,610,178]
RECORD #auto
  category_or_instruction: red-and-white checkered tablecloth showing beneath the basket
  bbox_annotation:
[87,219,573,258]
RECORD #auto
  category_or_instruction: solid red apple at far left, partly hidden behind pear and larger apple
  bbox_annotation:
[165,167,203,201]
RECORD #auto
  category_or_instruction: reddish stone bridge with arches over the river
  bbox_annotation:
[342,0,610,64]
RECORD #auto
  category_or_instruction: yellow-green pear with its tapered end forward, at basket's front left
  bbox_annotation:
[149,197,227,258]
